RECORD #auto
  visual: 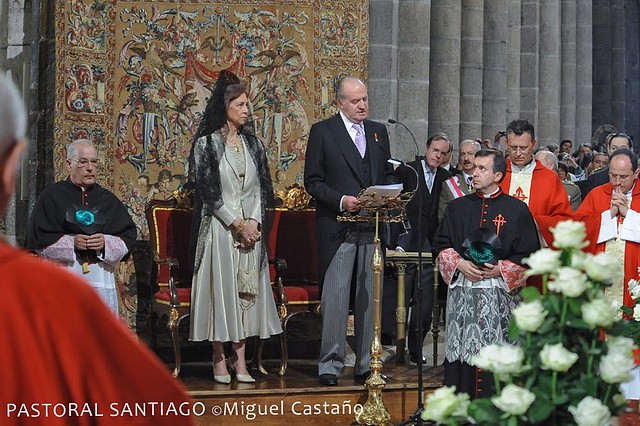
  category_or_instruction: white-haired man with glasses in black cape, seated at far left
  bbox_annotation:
[26,139,137,315]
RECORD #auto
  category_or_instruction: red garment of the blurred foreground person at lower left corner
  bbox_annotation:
[0,242,192,425]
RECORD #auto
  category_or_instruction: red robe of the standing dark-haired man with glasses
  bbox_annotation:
[500,161,573,247]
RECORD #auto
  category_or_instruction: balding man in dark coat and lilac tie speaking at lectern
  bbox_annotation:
[304,76,394,386]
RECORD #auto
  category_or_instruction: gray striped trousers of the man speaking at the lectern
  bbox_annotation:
[318,231,374,376]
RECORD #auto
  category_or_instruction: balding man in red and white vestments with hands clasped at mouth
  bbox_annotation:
[575,148,640,307]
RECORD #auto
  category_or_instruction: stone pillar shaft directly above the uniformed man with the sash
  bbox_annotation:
[454,0,484,142]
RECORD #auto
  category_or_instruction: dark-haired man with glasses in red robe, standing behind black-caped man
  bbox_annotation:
[500,120,573,247]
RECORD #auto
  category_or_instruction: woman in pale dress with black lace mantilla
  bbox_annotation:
[189,70,282,384]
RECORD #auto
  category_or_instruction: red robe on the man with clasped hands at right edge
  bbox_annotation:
[575,179,640,307]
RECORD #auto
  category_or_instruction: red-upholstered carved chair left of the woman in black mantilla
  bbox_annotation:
[146,191,193,377]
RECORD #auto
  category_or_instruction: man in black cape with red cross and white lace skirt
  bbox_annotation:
[433,149,540,398]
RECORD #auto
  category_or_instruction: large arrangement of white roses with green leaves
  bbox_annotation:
[422,221,640,426]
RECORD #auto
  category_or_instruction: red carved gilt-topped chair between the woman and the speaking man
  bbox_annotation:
[260,184,321,375]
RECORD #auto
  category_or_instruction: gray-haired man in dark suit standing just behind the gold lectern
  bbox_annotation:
[396,133,452,363]
